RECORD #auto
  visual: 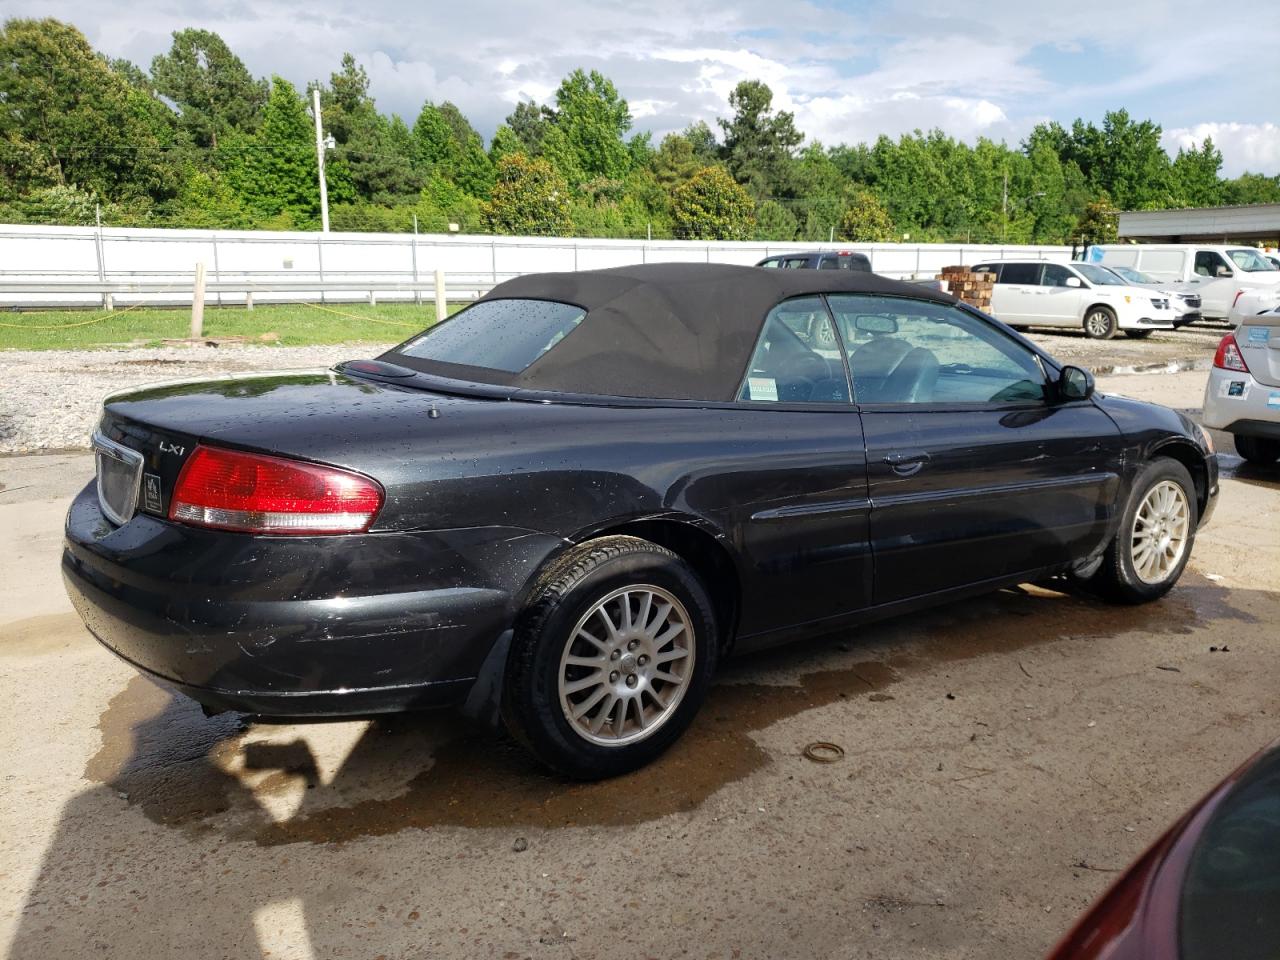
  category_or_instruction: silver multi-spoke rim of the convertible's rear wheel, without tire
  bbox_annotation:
[558,584,696,746]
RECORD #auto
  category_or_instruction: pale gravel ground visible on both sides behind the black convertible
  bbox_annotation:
[0,325,1226,454]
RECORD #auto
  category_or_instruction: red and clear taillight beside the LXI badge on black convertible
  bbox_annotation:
[169,447,383,534]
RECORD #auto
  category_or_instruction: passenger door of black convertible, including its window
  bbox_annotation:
[829,294,1121,605]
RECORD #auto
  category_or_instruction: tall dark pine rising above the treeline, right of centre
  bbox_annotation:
[719,81,804,200]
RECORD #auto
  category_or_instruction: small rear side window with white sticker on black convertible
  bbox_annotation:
[737,297,849,403]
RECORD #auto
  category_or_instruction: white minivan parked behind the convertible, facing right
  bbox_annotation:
[973,260,1185,340]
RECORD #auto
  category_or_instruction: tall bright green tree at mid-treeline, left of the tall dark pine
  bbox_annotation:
[556,69,631,179]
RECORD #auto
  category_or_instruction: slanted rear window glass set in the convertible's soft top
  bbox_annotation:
[398,300,586,374]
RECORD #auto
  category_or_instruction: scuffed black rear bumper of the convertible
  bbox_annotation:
[63,484,559,717]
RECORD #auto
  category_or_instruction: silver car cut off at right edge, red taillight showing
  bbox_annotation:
[1204,308,1280,466]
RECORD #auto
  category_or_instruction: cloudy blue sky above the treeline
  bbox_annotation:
[10,0,1280,175]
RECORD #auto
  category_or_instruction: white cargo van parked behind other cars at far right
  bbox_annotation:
[1085,243,1280,320]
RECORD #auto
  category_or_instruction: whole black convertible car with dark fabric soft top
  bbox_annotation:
[63,264,1217,777]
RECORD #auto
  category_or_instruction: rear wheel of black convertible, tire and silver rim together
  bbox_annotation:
[502,536,718,780]
